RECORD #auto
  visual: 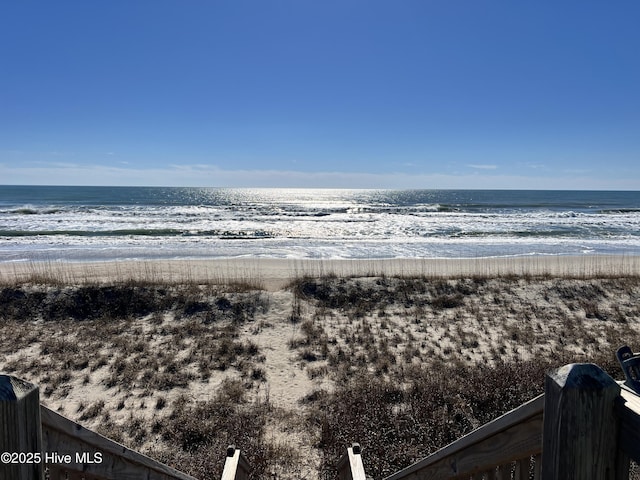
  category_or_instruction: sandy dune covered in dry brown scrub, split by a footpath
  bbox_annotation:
[0,276,640,479]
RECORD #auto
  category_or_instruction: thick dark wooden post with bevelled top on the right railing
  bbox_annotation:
[542,363,620,480]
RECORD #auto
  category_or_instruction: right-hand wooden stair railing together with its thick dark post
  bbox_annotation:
[340,357,640,480]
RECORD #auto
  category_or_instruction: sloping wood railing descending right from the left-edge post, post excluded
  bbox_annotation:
[40,406,195,480]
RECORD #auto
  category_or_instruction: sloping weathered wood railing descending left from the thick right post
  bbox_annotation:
[385,396,544,480]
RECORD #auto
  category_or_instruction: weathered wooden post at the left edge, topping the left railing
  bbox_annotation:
[0,375,44,480]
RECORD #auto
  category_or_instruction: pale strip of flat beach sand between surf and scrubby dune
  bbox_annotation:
[0,255,640,291]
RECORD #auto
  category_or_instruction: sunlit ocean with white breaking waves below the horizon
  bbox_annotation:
[0,186,640,262]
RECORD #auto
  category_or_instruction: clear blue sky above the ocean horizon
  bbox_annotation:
[0,0,640,190]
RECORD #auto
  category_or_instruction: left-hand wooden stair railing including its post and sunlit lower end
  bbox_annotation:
[0,375,249,480]
